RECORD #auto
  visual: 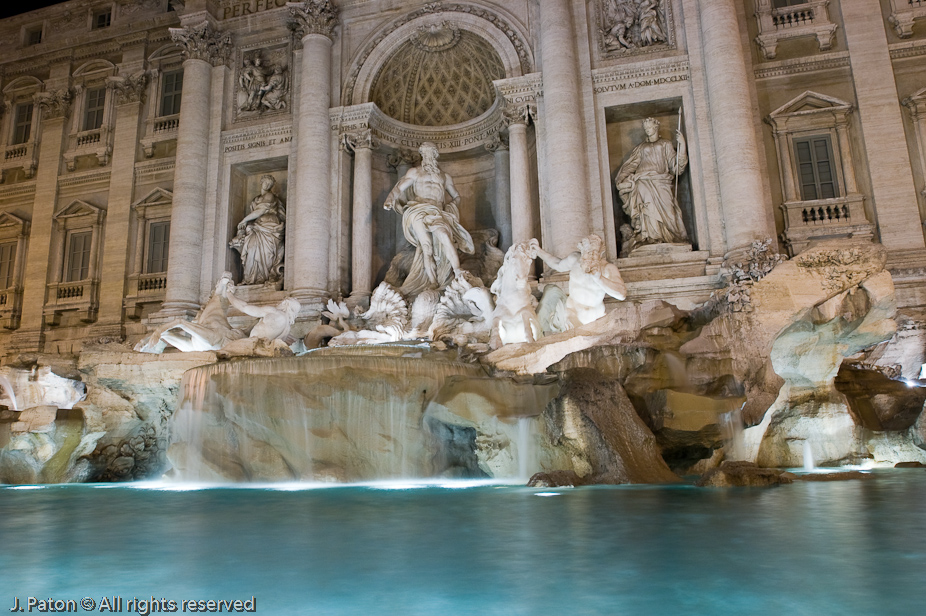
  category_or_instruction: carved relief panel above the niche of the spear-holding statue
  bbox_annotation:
[601,0,668,51]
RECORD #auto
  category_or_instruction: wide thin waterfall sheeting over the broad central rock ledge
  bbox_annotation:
[175,350,485,481]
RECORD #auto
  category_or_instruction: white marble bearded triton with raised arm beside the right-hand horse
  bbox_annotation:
[529,234,627,328]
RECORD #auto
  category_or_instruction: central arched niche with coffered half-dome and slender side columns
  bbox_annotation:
[331,4,539,300]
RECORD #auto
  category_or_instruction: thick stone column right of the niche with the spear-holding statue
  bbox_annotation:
[698,0,775,254]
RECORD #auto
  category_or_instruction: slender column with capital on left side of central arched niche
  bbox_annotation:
[344,129,375,304]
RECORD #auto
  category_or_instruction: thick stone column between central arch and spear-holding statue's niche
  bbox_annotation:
[536,0,596,254]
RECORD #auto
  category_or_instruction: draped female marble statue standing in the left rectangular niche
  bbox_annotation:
[228,175,286,284]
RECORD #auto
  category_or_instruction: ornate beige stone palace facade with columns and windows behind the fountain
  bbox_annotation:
[0,0,926,357]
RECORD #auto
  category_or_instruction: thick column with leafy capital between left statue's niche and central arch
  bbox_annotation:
[287,0,338,309]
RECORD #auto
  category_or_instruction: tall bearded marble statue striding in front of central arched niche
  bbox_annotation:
[383,142,474,296]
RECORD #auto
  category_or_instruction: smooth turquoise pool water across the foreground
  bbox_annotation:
[0,469,926,616]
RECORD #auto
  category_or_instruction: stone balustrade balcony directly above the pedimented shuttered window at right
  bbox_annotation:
[756,0,837,60]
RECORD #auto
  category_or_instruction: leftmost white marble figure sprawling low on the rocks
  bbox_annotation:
[135,272,244,353]
